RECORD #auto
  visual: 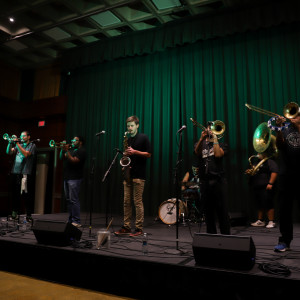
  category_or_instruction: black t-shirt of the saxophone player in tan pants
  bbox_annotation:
[128,133,151,179]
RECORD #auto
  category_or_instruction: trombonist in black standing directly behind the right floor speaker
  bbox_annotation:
[194,124,230,235]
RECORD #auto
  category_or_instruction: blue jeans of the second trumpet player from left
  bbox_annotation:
[64,179,82,224]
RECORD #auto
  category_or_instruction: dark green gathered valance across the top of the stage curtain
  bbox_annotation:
[62,0,300,71]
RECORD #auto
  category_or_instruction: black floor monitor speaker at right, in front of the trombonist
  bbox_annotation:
[193,233,256,270]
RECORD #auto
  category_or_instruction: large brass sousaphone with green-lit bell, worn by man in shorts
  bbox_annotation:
[246,122,277,176]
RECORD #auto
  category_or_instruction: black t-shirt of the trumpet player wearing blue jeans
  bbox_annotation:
[64,147,86,180]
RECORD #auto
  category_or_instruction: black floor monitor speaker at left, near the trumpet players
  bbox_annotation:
[32,220,82,246]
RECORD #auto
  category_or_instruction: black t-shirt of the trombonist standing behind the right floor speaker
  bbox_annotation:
[197,140,228,180]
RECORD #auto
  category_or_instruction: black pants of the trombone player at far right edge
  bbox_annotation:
[278,174,299,246]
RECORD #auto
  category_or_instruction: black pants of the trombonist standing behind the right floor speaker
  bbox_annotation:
[200,178,230,234]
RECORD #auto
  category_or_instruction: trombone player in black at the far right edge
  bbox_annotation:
[274,113,300,252]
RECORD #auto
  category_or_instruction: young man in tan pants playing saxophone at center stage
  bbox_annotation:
[115,116,151,236]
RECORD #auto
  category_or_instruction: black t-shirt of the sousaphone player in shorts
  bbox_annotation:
[249,158,279,189]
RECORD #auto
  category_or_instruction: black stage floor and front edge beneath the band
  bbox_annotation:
[0,213,300,299]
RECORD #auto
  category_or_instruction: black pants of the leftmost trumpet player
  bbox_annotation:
[10,174,35,216]
